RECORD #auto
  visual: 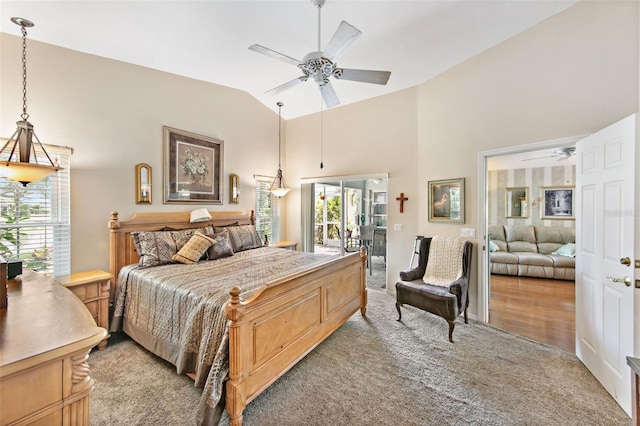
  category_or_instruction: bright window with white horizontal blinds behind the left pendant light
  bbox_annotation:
[0,145,72,275]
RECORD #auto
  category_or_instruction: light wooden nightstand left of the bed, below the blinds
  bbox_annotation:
[55,270,113,350]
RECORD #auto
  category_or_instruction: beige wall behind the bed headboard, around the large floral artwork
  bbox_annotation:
[0,33,278,272]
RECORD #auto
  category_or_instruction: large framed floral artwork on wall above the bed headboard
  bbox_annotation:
[163,126,224,204]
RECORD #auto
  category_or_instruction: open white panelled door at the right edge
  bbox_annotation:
[576,115,636,414]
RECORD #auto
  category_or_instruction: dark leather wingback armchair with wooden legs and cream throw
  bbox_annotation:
[396,237,473,343]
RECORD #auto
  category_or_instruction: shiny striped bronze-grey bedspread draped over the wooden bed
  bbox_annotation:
[111,247,332,425]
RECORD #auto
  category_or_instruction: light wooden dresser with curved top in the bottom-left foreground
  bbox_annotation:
[0,270,107,426]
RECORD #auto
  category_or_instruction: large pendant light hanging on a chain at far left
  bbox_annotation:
[0,18,62,186]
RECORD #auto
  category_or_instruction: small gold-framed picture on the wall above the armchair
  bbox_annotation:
[429,178,464,223]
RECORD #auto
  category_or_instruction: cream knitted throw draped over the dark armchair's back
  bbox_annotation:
[422,236,464,287]
